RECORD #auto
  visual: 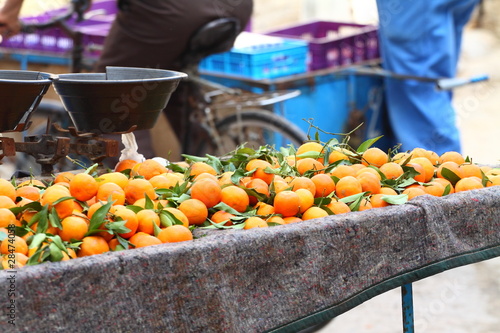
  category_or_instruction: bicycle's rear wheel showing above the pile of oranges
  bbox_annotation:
[198,109,307,156]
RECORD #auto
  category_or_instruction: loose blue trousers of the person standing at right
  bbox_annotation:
[377,0,479,154]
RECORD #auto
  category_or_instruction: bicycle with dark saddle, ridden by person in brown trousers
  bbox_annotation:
[3,0,307,175]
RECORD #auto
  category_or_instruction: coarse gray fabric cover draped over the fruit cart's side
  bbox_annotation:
[0,187,500,333]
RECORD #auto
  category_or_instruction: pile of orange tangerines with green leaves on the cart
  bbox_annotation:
[0,141,500,269]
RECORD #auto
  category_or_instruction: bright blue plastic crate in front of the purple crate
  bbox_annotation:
[200,32,308,80]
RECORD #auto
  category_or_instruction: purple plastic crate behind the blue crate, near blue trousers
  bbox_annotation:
[267,21,379,70]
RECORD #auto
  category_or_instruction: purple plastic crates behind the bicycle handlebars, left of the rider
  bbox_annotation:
[0,0,118,57]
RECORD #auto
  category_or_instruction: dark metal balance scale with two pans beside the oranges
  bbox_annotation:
[0,67,187,175]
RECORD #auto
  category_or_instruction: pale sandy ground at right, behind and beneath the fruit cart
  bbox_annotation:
[319,29,500,333]
